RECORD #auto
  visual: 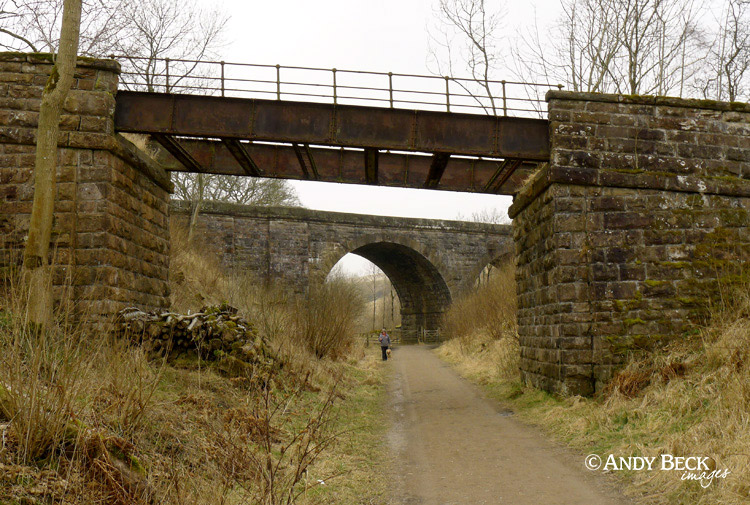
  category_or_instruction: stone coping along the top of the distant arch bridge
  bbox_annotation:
[170,200,512,235]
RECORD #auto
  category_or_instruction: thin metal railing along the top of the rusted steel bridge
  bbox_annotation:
[112,55,562,116]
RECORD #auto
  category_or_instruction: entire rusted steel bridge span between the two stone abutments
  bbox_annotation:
[115,91,549,194]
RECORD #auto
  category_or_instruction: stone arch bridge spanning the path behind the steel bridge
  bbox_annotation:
[171,202,514,336]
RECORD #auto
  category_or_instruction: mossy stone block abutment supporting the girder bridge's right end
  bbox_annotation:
[511,92,750,394]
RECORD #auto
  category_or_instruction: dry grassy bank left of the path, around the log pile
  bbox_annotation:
[0,229,386,505]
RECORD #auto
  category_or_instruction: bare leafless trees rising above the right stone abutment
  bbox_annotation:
[431,0,750,100]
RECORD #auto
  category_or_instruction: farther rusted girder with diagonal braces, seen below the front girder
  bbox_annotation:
[147,138,536,195]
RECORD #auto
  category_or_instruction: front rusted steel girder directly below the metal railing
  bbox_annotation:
[115,91,549,159]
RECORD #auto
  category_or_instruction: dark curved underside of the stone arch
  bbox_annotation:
[324,240,451,341]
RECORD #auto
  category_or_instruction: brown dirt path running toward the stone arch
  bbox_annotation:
[386,346,627,505]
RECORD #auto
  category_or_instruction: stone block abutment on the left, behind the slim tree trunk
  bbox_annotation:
[0,53,172,318]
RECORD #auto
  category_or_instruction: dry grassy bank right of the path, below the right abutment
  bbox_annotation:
[436,266,750,505]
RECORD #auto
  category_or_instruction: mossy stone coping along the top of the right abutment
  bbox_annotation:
[545,90,750,112]
